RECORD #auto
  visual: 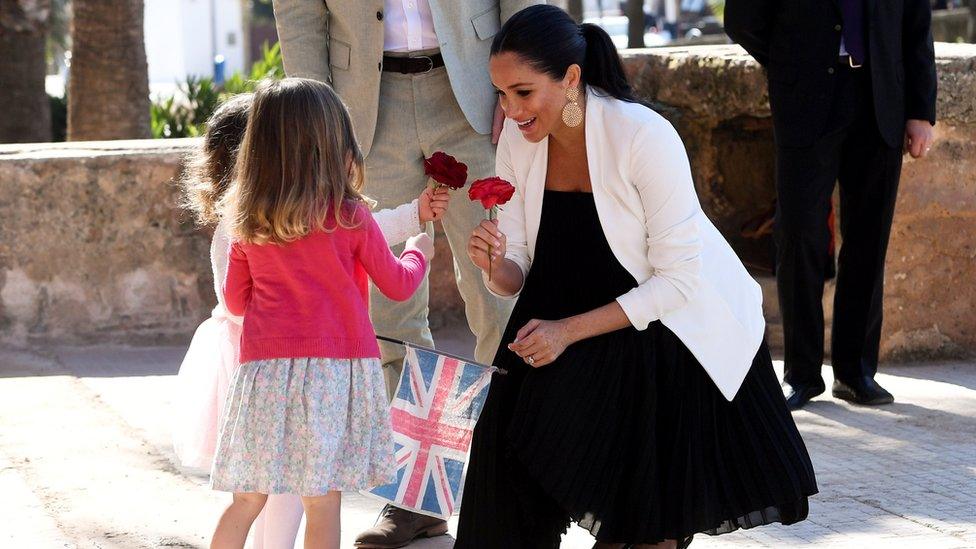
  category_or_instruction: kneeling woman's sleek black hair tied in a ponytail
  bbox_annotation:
[491,4,643,104]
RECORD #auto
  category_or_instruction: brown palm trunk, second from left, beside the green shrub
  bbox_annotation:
[68,0,150,141]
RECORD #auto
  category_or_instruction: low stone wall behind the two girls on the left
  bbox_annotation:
[0,139,466,344]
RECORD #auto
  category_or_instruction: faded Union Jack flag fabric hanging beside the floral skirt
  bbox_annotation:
[365,345,497,519]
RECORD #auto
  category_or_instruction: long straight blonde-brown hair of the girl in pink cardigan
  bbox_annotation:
[222,78,371,244]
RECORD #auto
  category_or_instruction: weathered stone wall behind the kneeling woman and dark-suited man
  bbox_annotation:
[624,43,976,359]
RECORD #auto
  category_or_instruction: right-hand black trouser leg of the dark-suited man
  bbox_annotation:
[831,80,902,380]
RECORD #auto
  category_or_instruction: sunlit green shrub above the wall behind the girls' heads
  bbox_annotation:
[150,42,285,139]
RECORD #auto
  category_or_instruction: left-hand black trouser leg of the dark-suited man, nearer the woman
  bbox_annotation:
[773,131,844,387]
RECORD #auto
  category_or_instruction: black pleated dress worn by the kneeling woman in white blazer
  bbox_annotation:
[455,191,817,549]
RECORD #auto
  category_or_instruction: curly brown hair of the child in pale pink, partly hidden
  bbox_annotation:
[180,93,254,225]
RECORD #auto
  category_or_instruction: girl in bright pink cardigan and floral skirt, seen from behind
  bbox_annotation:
[211,78,433,548]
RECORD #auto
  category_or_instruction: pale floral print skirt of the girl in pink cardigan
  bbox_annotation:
[210,358,395,496]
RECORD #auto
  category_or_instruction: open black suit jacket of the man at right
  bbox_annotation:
[725,0,936,148]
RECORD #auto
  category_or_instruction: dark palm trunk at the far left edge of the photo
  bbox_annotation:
[0,0,51,143]
